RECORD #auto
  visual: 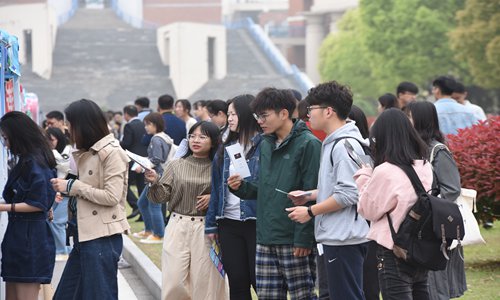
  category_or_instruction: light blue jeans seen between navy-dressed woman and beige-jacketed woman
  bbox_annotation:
[49,197,71,254]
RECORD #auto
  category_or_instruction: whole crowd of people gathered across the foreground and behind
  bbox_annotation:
[0,76,486,300]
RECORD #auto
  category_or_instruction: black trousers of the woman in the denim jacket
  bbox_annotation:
[218,219,256,300]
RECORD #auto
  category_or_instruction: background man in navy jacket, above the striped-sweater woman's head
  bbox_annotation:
[158,94,186,145]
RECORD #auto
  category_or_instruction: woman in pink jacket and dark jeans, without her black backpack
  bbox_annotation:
[354,108,432,300]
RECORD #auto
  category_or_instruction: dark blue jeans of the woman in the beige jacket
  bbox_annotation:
[53,234,123,300]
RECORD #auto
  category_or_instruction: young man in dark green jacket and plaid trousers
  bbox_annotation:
[228,88,321,300]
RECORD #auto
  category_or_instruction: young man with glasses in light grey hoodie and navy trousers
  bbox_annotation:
[288,81,369,299]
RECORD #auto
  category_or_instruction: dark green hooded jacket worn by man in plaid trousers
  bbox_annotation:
[232,120,321,248]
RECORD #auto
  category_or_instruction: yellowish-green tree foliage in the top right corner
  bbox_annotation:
[450,0,500,88]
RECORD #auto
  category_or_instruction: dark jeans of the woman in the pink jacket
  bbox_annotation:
[377,245,429,300]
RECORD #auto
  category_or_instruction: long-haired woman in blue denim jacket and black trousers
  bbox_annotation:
[205,95,261,300]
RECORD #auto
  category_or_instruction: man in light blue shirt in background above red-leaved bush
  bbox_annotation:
[432,76,479,135]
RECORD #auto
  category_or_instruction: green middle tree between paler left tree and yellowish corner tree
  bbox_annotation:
[360,0,466,92]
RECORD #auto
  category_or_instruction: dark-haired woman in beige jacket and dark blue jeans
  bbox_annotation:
[52,99,130,300]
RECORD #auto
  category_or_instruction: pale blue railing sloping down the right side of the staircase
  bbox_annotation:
[225,18,314,93]
